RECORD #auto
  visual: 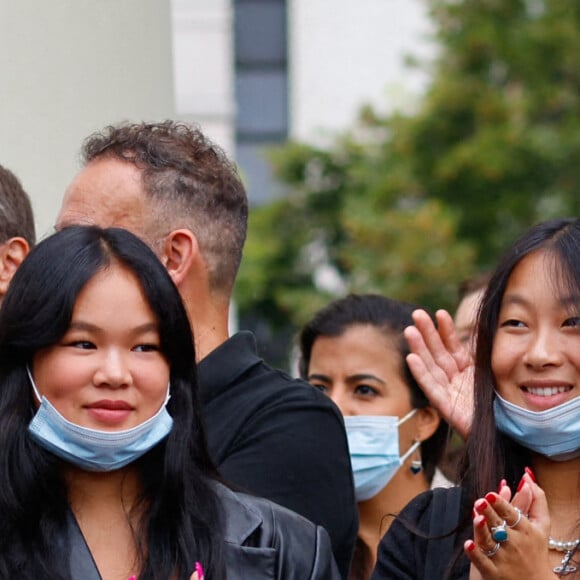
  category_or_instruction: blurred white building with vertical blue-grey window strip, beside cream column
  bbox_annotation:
[172,0,432,204]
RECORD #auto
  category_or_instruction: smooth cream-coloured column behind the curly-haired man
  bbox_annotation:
[0,0,174,237]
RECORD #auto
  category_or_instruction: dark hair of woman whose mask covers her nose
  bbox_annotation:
[298,294,449,481]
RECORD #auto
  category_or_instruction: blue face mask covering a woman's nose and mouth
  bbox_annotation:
[344,409,421,501]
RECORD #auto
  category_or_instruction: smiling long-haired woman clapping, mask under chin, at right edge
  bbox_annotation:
[372,218,580,580]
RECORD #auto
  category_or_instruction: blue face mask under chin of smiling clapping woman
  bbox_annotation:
[493,391,580,461]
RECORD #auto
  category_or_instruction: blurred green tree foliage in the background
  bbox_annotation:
[236,0,580,336]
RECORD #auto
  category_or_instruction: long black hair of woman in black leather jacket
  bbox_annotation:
[0,226,224,580]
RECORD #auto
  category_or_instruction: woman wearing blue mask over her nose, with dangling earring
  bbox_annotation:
[299,294,449,580]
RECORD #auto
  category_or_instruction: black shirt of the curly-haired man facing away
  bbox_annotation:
[198,331,358,578]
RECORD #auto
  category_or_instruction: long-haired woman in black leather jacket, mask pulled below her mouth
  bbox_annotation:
[0,226,338,580]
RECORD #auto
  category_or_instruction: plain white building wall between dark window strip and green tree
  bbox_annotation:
[288,0,434,141]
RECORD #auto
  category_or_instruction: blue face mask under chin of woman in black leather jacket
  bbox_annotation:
[26,368,173,471]
